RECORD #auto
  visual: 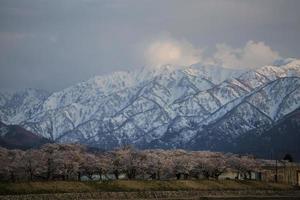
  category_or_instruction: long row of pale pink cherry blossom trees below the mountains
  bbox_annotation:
[0,144,259,181]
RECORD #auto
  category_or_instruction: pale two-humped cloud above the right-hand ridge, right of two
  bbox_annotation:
[209,40,279,68]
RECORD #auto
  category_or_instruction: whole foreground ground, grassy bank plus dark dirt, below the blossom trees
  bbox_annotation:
[0,180,300,200]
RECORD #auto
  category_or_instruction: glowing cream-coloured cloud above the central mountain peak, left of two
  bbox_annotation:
[145,38,202,67]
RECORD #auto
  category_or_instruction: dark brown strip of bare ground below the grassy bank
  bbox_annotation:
[0,190,300,200]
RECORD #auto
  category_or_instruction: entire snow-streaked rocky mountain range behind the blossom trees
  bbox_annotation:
[0,59,300,156]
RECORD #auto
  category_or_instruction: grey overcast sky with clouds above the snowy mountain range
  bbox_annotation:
[0,0,300,91]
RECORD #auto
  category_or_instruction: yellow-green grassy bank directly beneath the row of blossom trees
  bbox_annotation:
[0,180,295,195]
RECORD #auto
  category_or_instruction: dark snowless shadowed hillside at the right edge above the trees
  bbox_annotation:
[231,109,300,161]
